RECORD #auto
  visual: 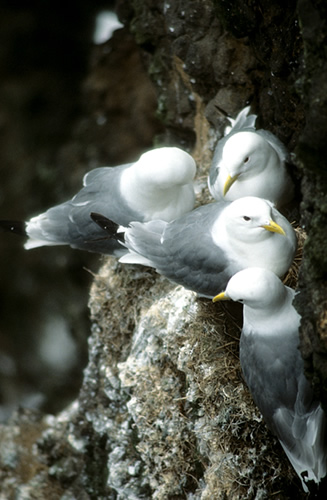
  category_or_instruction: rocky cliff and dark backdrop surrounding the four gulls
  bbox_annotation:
[0,0,327,500]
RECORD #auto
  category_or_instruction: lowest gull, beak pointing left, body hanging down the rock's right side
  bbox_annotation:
[213,267,327,492]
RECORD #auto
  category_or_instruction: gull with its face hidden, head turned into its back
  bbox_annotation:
[0,147,196,256]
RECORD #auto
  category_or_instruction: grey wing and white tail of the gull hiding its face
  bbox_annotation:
[27,165,143,255]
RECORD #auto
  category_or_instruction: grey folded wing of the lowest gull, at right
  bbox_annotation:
[240,326,318,454]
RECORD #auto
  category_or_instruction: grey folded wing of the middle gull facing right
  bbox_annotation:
[128,203,235,297]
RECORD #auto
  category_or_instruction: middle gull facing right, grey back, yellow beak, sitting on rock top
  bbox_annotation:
[91,197,297,298]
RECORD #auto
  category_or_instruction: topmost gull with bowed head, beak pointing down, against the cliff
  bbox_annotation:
[208,106,294,208]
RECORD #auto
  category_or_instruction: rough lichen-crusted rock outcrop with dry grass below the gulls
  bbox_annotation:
[0,259,301,500]
